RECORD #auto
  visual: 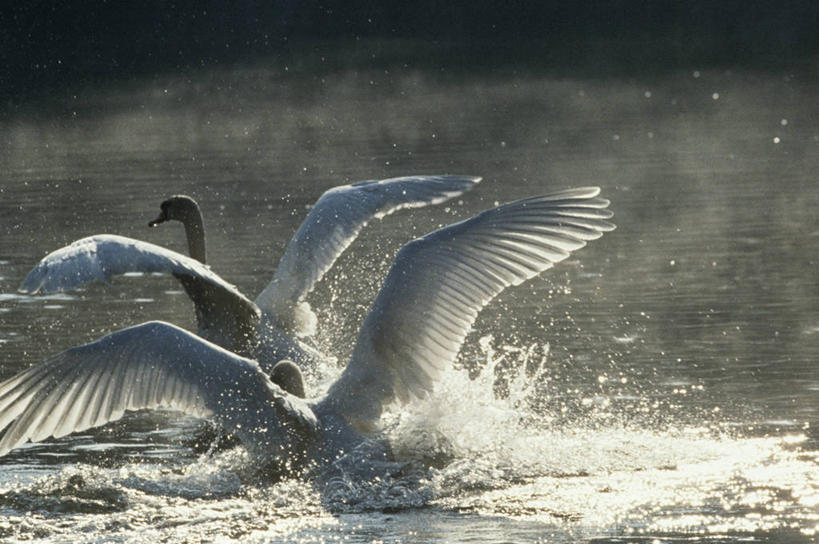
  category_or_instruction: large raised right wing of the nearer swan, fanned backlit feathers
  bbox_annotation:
[324,187,614,421]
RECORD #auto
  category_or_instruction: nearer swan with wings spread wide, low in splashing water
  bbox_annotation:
[0,187,615,474]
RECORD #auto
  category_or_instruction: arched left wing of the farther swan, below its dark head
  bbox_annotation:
[20,234,259,354]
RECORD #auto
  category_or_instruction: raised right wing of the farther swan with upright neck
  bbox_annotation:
[256,176,481,332]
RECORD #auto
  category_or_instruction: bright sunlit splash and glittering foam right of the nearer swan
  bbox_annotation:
[390,337,819,536]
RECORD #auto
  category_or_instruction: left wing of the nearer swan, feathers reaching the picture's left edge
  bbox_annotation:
[0,321,316,457]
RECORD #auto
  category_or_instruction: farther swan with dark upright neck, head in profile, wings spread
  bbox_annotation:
[20,175,481,372]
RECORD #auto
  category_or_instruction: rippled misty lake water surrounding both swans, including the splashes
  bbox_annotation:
[0,63,819,543]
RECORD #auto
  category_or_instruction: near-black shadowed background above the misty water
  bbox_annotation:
[0,0,819,110]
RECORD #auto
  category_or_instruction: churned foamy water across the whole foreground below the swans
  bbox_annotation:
[0,336,819,542]
